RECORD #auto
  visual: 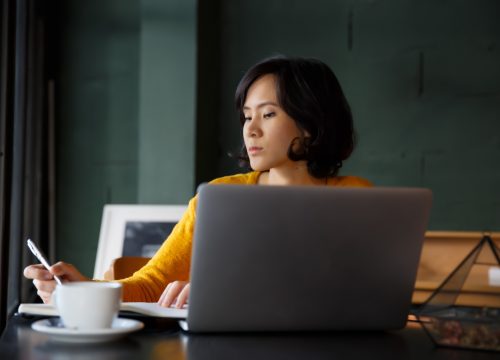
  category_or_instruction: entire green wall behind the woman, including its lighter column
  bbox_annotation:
[57,0,500,275]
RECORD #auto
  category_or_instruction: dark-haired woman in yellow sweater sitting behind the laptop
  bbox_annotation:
[24,57,371,307]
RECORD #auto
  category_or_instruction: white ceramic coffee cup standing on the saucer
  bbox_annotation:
[53,281,122,330]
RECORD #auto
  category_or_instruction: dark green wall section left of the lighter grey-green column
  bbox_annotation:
[56,0,140,275]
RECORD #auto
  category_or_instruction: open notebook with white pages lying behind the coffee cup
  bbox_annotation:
[17,302,188,319]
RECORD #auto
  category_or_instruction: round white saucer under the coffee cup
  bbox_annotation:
[31,318,144,343]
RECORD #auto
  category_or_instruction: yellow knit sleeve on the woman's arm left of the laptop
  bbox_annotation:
[118,196,197,302]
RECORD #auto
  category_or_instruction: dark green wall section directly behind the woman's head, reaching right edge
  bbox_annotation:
[213,0,500,230]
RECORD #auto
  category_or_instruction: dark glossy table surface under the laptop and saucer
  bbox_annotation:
[0,315,500,360]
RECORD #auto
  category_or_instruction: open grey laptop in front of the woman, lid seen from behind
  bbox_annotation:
[181,185,432,332]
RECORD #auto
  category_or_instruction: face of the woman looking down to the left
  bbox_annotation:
[243,74,303,171]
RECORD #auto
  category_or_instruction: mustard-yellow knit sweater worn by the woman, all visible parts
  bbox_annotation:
[119,171,371,302]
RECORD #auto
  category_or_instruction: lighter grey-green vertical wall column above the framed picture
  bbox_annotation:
[137,0,196,204]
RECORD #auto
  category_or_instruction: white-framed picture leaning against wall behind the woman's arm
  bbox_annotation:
[94,205,187,279]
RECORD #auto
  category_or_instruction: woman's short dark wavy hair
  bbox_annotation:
[235,56,355,178]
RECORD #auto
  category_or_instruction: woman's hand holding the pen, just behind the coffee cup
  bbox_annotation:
[23,261,90,304]
